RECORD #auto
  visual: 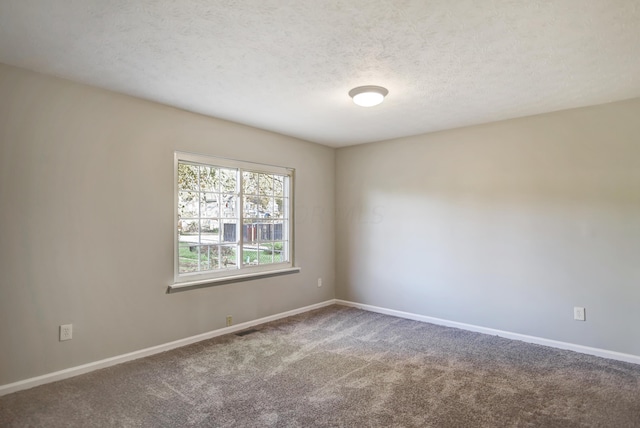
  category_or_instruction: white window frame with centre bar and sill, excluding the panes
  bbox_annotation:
[168,151,300,293]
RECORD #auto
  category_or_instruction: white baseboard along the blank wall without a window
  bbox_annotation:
[335,299,640,364]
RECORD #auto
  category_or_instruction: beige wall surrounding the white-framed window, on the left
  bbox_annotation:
[0,65,335,385]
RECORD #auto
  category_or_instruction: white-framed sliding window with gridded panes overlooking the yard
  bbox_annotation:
[170,152,293,290]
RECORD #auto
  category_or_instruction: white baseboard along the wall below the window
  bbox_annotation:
[0,299,336,396]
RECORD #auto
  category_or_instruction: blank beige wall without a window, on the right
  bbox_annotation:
[336,99,640,355]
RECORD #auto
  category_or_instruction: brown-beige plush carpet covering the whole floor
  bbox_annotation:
[0,306,640,428]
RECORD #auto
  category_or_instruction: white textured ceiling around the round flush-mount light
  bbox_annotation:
[0,0,640,147]
